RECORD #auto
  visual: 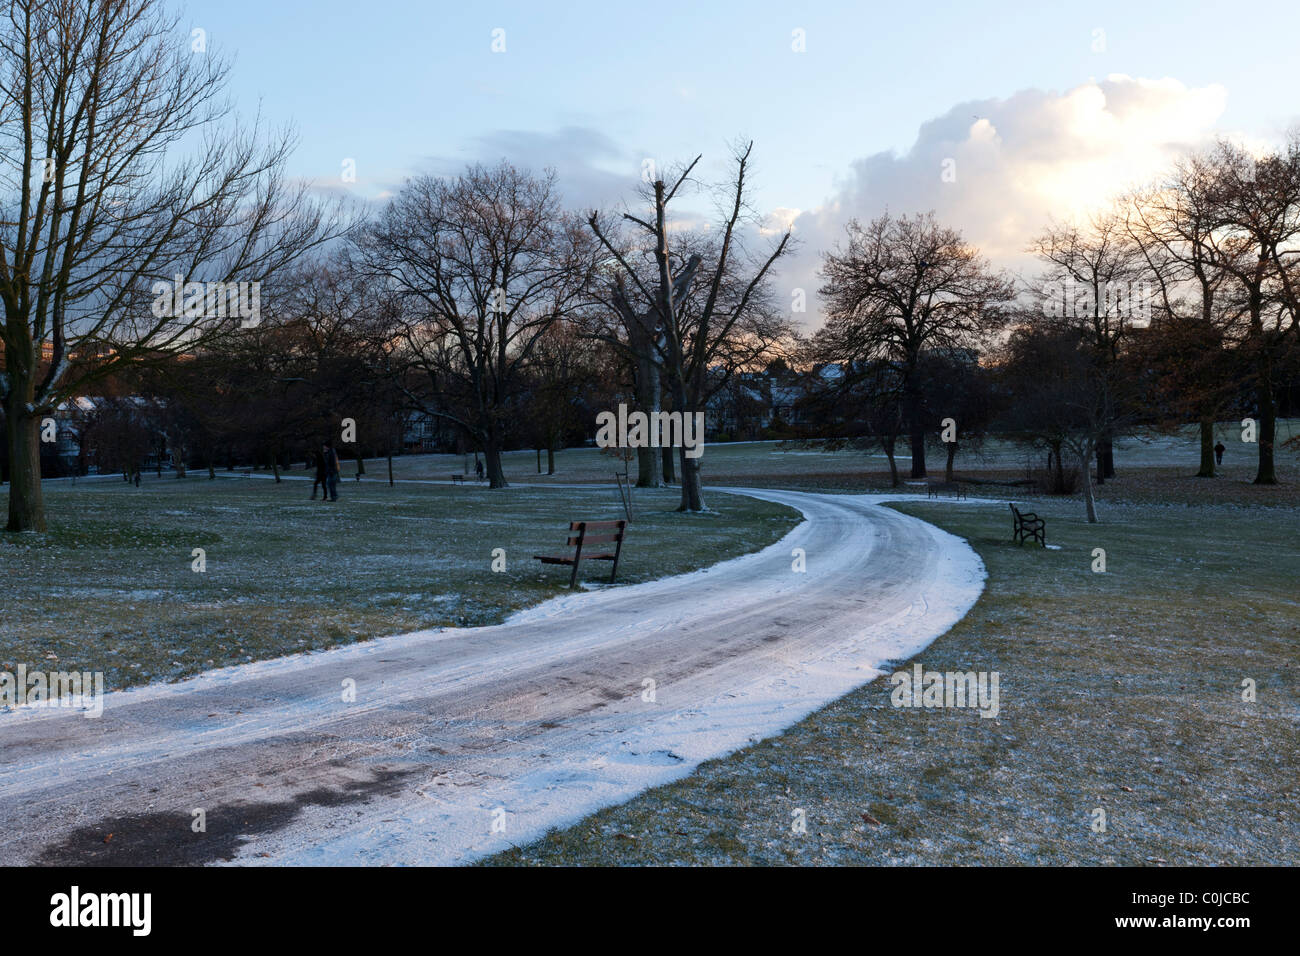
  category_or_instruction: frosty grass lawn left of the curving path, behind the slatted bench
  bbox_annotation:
[0,475,798,689]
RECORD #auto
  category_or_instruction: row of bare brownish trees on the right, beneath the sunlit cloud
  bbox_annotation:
[802,137,1300,520]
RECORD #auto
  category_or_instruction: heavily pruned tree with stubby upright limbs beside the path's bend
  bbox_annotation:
[588,142,790,511]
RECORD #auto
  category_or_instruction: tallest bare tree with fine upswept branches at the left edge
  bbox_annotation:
[0,0,333,531]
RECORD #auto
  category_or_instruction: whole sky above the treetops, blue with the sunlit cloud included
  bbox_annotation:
[183,0,1300,323]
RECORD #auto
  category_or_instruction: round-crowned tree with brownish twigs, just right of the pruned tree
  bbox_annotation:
[818,212,1015,477]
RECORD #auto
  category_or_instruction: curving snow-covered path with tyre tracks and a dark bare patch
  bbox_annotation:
[0,489,984,864]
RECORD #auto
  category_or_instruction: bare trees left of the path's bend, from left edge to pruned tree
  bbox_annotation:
[0,0,788,532]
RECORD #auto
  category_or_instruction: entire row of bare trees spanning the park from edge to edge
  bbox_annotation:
[0,0,1300,531]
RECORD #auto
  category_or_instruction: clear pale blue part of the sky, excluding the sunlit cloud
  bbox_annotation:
[182,0,1300,208]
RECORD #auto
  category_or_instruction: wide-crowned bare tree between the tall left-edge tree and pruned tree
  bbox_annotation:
[355,163,595,488]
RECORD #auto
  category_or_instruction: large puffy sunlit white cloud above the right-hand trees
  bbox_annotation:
[774,74,1227,329]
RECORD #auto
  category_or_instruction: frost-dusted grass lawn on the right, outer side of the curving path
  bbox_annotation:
[488,496,1300,865]
